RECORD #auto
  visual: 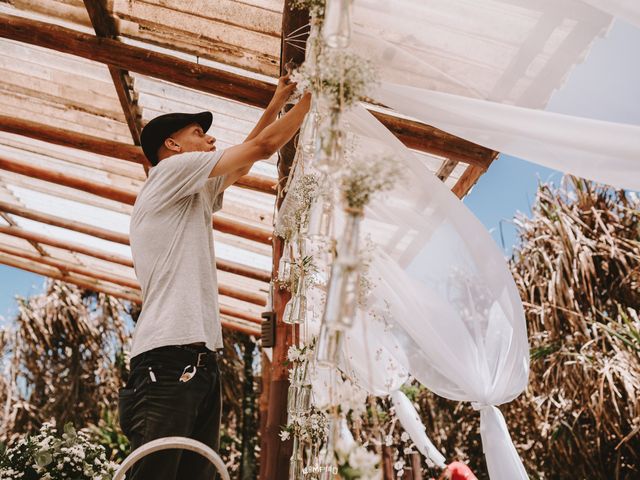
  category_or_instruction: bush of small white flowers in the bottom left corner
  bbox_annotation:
[0,423,118,480]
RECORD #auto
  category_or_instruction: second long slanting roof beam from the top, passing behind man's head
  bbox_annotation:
[0,114,276,195]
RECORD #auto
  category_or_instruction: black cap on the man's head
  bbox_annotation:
[140,112,213,165]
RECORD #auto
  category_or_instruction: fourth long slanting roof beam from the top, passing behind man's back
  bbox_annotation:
[0,201,271,283]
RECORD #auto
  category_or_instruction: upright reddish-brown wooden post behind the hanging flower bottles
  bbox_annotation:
[260,0,309,480]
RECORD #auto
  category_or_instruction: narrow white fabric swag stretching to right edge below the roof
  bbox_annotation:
[376,83,640,190]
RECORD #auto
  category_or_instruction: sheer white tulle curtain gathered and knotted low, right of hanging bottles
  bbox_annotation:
[300,107,529,480]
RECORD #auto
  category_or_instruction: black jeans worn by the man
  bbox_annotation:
[118,346,222,480]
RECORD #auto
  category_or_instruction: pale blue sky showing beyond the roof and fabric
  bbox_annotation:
[0,18,640,323]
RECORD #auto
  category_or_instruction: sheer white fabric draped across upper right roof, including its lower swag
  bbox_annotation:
[353,0,640,190]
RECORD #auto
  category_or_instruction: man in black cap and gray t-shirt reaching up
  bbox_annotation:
[119,77,310,480]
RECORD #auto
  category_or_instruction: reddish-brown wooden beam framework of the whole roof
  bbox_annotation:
[0,0,497,334]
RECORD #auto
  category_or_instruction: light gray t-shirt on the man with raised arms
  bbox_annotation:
[130,152,224,357]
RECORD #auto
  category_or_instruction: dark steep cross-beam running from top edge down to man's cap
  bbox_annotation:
[84,0,143,147]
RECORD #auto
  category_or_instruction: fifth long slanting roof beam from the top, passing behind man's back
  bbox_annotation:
[0,225,266,306]
